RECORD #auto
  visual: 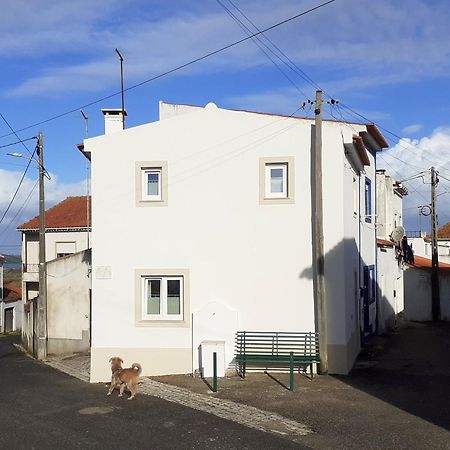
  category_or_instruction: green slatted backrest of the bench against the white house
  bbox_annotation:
[235,331,319,356]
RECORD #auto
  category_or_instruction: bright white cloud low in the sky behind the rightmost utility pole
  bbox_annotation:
[377,127,450,229]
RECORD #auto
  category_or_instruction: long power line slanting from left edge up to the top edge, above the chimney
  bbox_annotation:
[0,0,336,139]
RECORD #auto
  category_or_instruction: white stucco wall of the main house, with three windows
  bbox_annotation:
[85,102,375,381]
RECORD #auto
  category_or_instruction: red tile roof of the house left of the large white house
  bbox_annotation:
[17,196,91,231]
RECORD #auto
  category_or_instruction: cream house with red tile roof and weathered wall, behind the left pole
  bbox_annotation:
[17,196,91,354]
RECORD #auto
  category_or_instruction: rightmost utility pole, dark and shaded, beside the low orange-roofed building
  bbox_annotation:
[431,167,441,322]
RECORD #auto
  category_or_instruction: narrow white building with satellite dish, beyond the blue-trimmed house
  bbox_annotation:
[376,170,408,333]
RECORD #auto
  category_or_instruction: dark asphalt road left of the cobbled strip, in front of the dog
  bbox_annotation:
[0,337,307,450]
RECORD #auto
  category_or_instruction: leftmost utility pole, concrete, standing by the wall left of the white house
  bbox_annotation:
[37,131,47,360]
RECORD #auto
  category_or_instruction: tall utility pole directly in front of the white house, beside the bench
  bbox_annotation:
[311,90,328,374]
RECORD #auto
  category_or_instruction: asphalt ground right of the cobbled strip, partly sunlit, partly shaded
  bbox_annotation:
[152,323,450,450]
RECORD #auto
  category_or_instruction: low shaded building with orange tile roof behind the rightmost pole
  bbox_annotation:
[404,255,450,322]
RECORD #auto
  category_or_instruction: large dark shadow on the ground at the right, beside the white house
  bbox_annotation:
[336,322,450,432]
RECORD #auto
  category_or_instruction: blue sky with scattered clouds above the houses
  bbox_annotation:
[0,0,450,253]
